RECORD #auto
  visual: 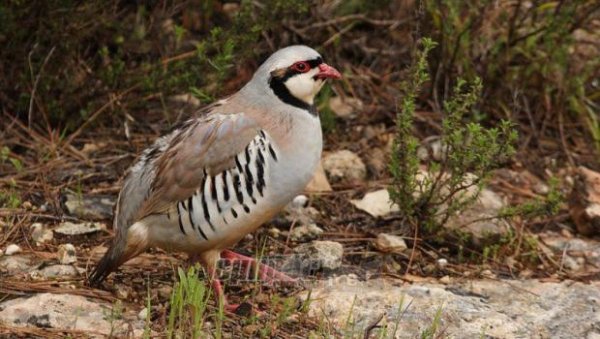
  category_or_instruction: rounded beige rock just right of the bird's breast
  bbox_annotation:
[323,150,367,182]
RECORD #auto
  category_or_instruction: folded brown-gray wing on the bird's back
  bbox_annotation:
[115,113,258,231]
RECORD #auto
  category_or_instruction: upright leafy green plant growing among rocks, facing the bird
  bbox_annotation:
[390,38,517,233]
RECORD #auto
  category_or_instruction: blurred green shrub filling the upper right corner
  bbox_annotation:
[422,0,600,150]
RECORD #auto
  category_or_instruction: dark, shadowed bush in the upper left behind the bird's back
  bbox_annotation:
[0,0,308,134]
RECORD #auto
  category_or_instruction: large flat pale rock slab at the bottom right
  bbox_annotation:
[303,276,600,338]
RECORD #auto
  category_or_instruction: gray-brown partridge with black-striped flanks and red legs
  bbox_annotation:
[88,45,341,312]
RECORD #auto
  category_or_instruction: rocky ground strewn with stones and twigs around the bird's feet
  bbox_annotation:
[0,142,600,338]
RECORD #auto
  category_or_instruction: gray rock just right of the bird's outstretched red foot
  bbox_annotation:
[283,241,344,276]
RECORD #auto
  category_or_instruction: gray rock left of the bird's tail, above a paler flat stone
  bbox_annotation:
[65,194,116,220]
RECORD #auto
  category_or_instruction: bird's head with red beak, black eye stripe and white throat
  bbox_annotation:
[250,45,341,109]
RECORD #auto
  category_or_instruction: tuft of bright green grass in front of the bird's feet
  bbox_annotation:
[167,267,211,338]
